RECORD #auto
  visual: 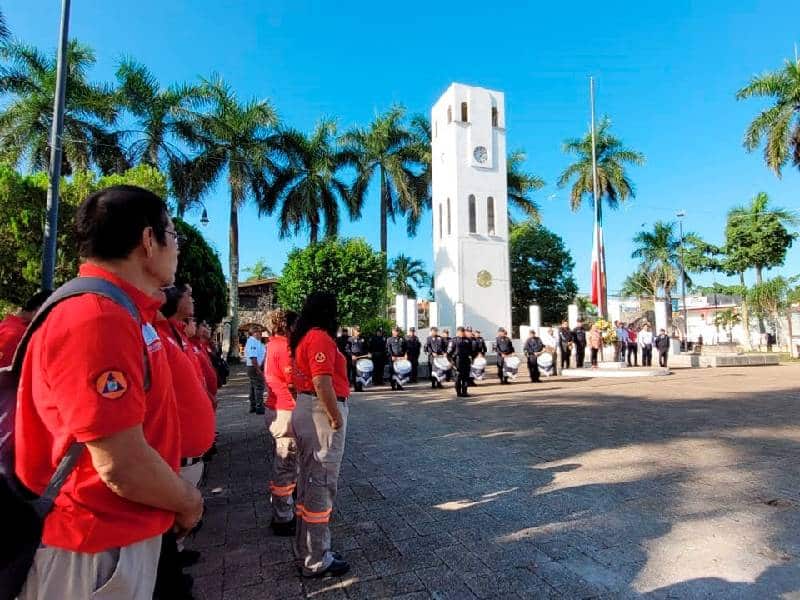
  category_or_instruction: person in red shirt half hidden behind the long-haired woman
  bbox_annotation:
[264,309,297,536]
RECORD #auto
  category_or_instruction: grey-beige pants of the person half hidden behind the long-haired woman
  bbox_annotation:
[267,409,297,523]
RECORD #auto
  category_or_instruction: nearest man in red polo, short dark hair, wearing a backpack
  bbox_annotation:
[15,186,203,600]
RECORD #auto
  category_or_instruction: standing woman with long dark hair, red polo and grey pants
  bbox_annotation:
[289,292,350,577]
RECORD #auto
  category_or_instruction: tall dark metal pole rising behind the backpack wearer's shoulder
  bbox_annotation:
[42,0,70,290]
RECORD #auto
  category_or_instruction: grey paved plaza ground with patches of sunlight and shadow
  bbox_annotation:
[189,365,800,600]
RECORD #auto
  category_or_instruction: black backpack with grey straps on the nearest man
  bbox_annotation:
[0,277,150,600]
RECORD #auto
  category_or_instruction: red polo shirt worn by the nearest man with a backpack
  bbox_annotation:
[15,264,180,553]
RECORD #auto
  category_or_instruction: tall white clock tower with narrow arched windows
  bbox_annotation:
[431,83,511,339]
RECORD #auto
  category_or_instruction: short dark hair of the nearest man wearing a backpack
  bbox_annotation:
[75,185,169,260]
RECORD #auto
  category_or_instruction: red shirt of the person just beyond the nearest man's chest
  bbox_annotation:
[156,319,216,458]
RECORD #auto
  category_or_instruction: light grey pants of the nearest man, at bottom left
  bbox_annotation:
[18,535,161,600]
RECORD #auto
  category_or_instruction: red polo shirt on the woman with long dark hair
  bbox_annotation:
[293,328,350,398]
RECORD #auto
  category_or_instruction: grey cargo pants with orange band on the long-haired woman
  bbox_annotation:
[292,394,349,574]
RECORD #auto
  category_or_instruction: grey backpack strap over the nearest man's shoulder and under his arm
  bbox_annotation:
[11,277,151,508]
